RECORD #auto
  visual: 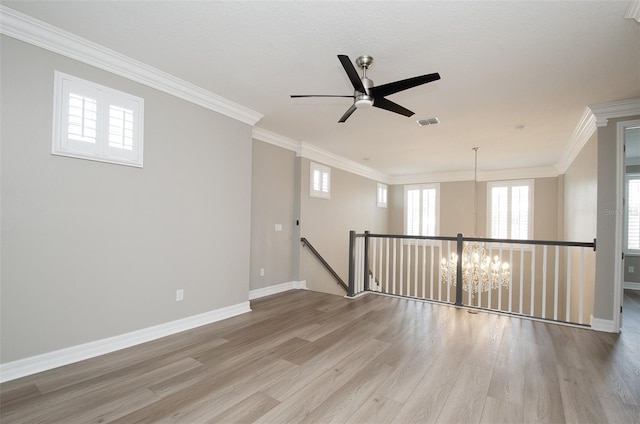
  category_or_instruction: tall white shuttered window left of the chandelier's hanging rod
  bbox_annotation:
[404,184,440,236]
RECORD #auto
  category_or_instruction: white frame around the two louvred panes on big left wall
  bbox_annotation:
[51,71,144,168]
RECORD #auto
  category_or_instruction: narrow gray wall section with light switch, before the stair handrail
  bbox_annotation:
[249,140,299,290]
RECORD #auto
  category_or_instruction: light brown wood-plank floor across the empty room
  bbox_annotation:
[0,290,640,424]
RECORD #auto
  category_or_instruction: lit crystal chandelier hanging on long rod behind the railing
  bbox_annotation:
[440,147,510,297]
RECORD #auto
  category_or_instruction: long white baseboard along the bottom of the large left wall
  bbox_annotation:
[0,302,251,383]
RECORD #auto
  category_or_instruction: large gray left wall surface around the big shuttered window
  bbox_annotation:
[0,37,251,363]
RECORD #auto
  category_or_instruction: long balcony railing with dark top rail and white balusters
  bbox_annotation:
[348,231,596,326]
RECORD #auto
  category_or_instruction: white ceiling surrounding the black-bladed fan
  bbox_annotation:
[2,1,640,176]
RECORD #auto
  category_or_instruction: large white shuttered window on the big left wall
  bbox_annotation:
[51,72,144,167]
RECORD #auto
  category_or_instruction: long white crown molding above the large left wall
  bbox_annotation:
[0,5,263,125]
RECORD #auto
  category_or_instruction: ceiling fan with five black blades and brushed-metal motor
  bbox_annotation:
[291,54,440,123]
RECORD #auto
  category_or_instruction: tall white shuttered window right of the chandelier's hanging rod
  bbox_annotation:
[487,180,533,240]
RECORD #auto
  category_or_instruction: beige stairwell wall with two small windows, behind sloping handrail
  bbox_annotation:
[298,158,389,295]
